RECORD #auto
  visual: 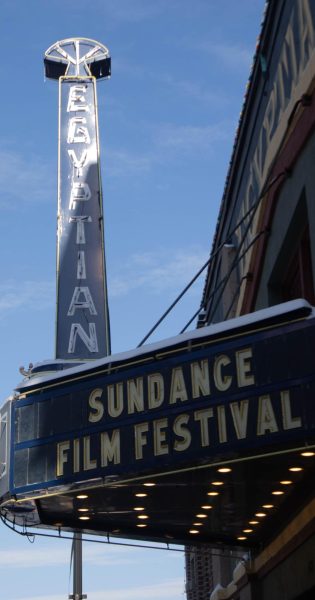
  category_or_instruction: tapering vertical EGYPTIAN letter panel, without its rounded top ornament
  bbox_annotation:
[56,77,108,359]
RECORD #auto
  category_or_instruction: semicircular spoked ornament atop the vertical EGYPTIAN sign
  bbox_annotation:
[44,38,111,79]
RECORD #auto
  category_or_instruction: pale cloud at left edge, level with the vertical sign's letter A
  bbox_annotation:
[0,280,55,317]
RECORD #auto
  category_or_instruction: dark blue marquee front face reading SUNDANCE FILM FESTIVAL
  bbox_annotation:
[11,302,315,494]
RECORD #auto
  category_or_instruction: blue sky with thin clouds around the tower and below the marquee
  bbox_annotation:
[0,0,264,600]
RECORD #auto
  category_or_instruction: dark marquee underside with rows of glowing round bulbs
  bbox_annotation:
[2,446,315,548]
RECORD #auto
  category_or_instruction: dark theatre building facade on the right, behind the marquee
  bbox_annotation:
[186,0,315,600]
